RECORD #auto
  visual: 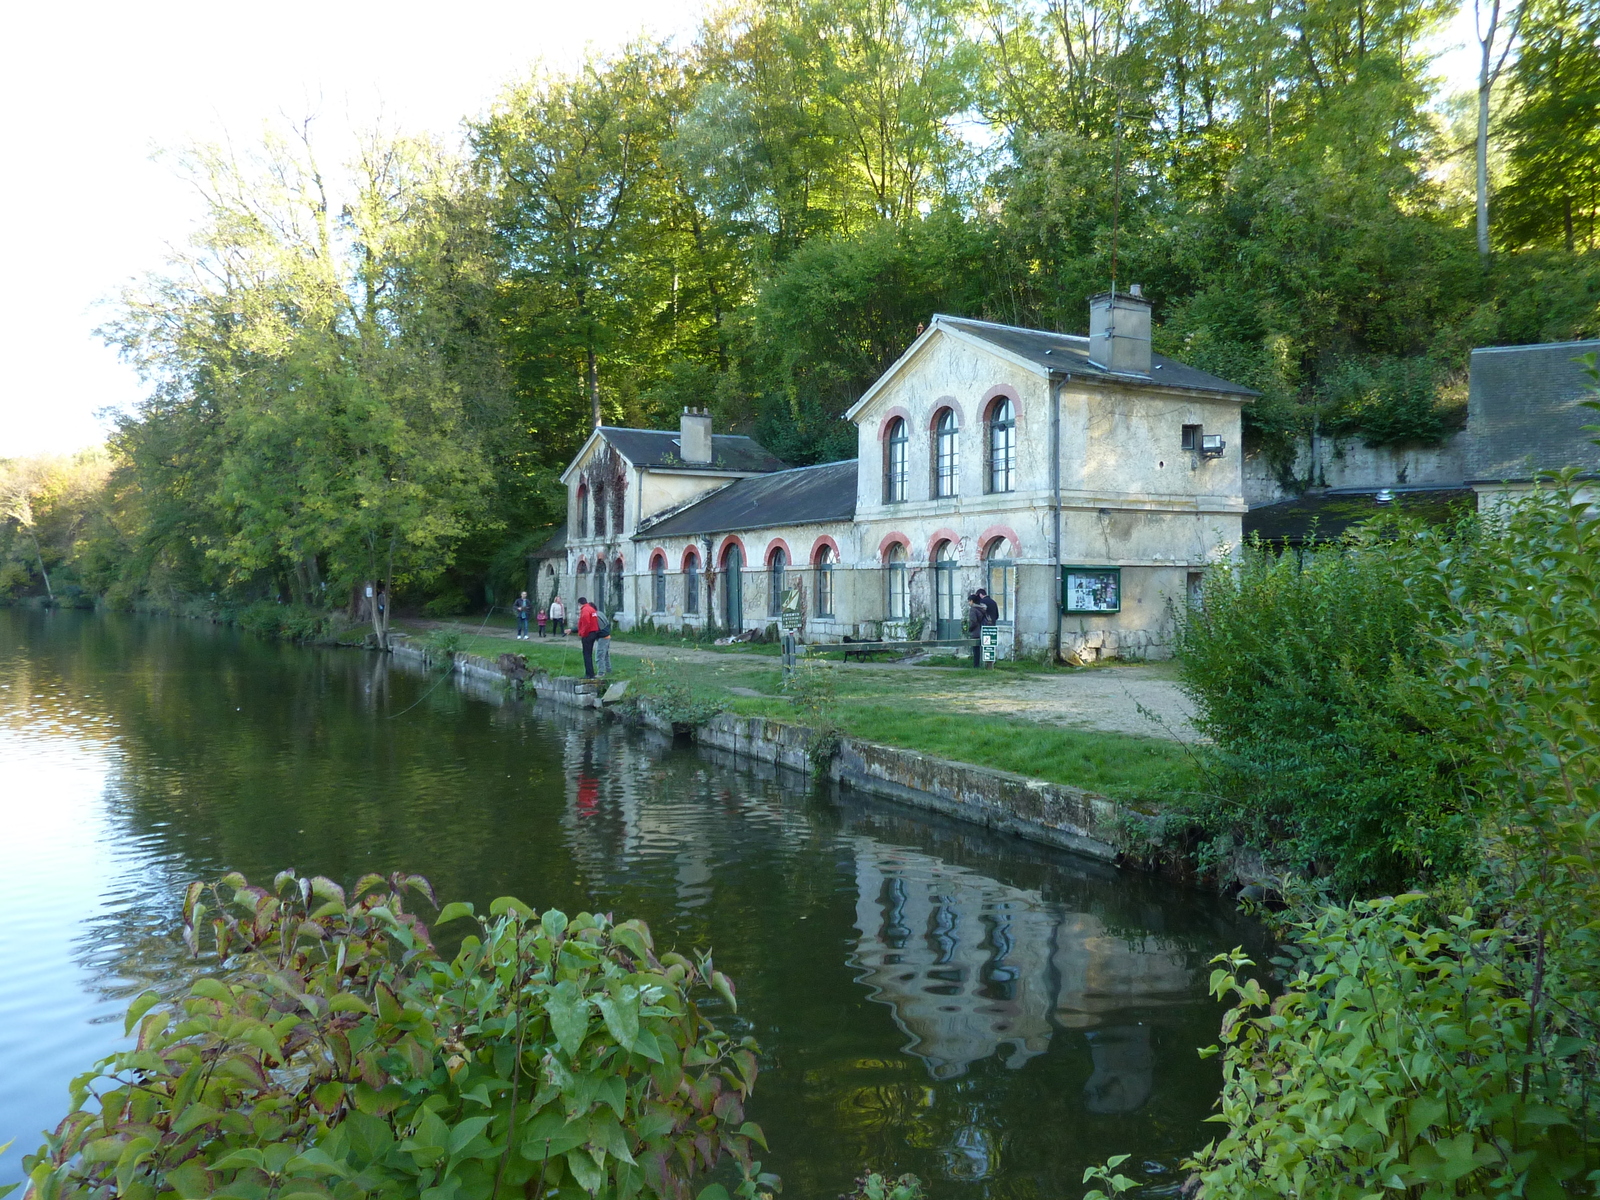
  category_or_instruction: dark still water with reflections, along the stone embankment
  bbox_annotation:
[0,610,1254,1200]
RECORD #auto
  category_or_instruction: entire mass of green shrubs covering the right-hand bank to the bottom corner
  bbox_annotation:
[1091,480,1600,1200]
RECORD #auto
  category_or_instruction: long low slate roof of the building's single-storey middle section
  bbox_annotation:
[634,459,856,541]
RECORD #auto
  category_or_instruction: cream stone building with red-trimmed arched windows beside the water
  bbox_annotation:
[556,290,1253,658]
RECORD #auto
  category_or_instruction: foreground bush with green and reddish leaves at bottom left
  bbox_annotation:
[26,872,776,1200]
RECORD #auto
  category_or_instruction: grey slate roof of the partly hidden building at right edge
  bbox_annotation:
[1467,341,1600,483]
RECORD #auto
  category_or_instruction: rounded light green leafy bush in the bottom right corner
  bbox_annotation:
[1190,894,1600,1200]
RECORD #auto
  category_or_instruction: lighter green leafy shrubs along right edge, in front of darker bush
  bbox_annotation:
[1145,475,1600,1200]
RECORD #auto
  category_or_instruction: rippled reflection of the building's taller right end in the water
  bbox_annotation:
[851,837,1197,1088]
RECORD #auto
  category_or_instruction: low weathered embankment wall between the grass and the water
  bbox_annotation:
[394,645,1125,862]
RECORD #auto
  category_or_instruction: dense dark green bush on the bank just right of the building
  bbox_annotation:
[1176,522,1483,893]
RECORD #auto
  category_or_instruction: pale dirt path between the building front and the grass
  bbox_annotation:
[400,621,1198,741]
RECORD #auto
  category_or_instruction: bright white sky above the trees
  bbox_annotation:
[0,0,1472,458]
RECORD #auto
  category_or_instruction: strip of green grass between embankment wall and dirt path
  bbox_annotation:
[406,634,1197,802]
